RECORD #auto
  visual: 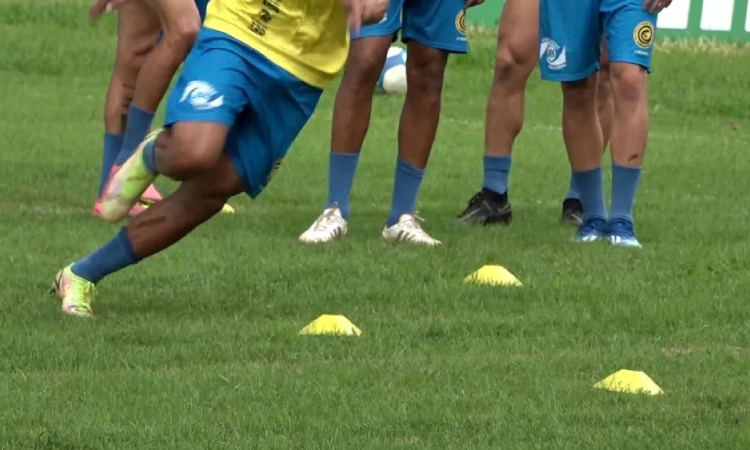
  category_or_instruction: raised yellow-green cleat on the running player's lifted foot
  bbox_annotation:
[101,130,161,222]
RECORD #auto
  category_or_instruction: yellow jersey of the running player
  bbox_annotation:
[204,0,349,89]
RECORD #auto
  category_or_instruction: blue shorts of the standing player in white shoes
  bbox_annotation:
[352,0,468,53]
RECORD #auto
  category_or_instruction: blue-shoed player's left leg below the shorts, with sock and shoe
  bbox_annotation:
[562,74,607,242]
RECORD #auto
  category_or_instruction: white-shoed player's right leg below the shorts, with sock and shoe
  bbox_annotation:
[383,40,448,246]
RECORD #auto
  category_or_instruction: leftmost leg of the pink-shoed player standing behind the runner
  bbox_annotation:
[93,6,159,216]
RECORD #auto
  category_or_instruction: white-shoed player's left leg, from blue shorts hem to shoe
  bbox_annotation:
[299,0,403,243]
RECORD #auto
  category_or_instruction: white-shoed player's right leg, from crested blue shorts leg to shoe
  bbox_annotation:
[383,0,467,246]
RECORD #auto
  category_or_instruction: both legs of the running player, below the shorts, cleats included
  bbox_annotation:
[55,122,243,317]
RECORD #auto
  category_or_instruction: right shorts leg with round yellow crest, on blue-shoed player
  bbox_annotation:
[603,0,657,71]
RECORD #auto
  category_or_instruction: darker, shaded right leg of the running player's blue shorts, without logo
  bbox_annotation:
[226,68,322,197]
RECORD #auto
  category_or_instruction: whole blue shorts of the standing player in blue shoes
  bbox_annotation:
[539,0,657,82]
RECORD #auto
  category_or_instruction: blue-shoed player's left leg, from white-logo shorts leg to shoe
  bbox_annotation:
[539,0,606,242]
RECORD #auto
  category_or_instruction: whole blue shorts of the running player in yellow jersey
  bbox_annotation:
[164,28,323,197]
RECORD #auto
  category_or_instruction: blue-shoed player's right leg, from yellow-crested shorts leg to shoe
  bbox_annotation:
[602,0,657,247]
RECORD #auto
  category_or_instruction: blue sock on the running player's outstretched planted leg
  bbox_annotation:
[71,227,140,284]
